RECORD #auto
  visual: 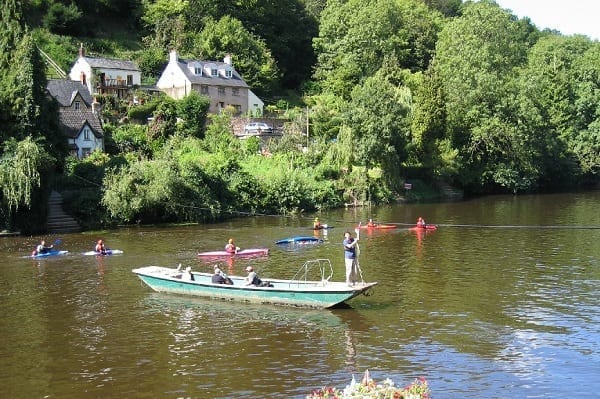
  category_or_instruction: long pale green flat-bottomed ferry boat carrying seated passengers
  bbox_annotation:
[133,266,377,309]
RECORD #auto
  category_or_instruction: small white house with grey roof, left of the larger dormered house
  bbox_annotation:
[69,44,142,98]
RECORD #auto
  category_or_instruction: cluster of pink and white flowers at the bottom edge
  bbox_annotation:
[306,370,431,399]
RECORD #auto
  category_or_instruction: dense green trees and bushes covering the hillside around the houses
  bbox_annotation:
[0,0,600,231]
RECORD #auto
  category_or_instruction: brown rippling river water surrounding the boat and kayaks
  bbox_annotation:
[0,192,600,399]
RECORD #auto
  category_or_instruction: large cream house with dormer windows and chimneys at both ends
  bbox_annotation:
[156,51,264,115]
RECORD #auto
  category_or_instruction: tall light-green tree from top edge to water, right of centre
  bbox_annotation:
[434,0,538,191]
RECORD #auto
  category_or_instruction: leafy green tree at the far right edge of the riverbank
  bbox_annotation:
[521,35,600,187]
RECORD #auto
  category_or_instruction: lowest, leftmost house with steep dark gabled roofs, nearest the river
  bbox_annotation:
[46,79,104,159]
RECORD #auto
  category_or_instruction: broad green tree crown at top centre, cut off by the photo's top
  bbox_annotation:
[314,0,442,99]
